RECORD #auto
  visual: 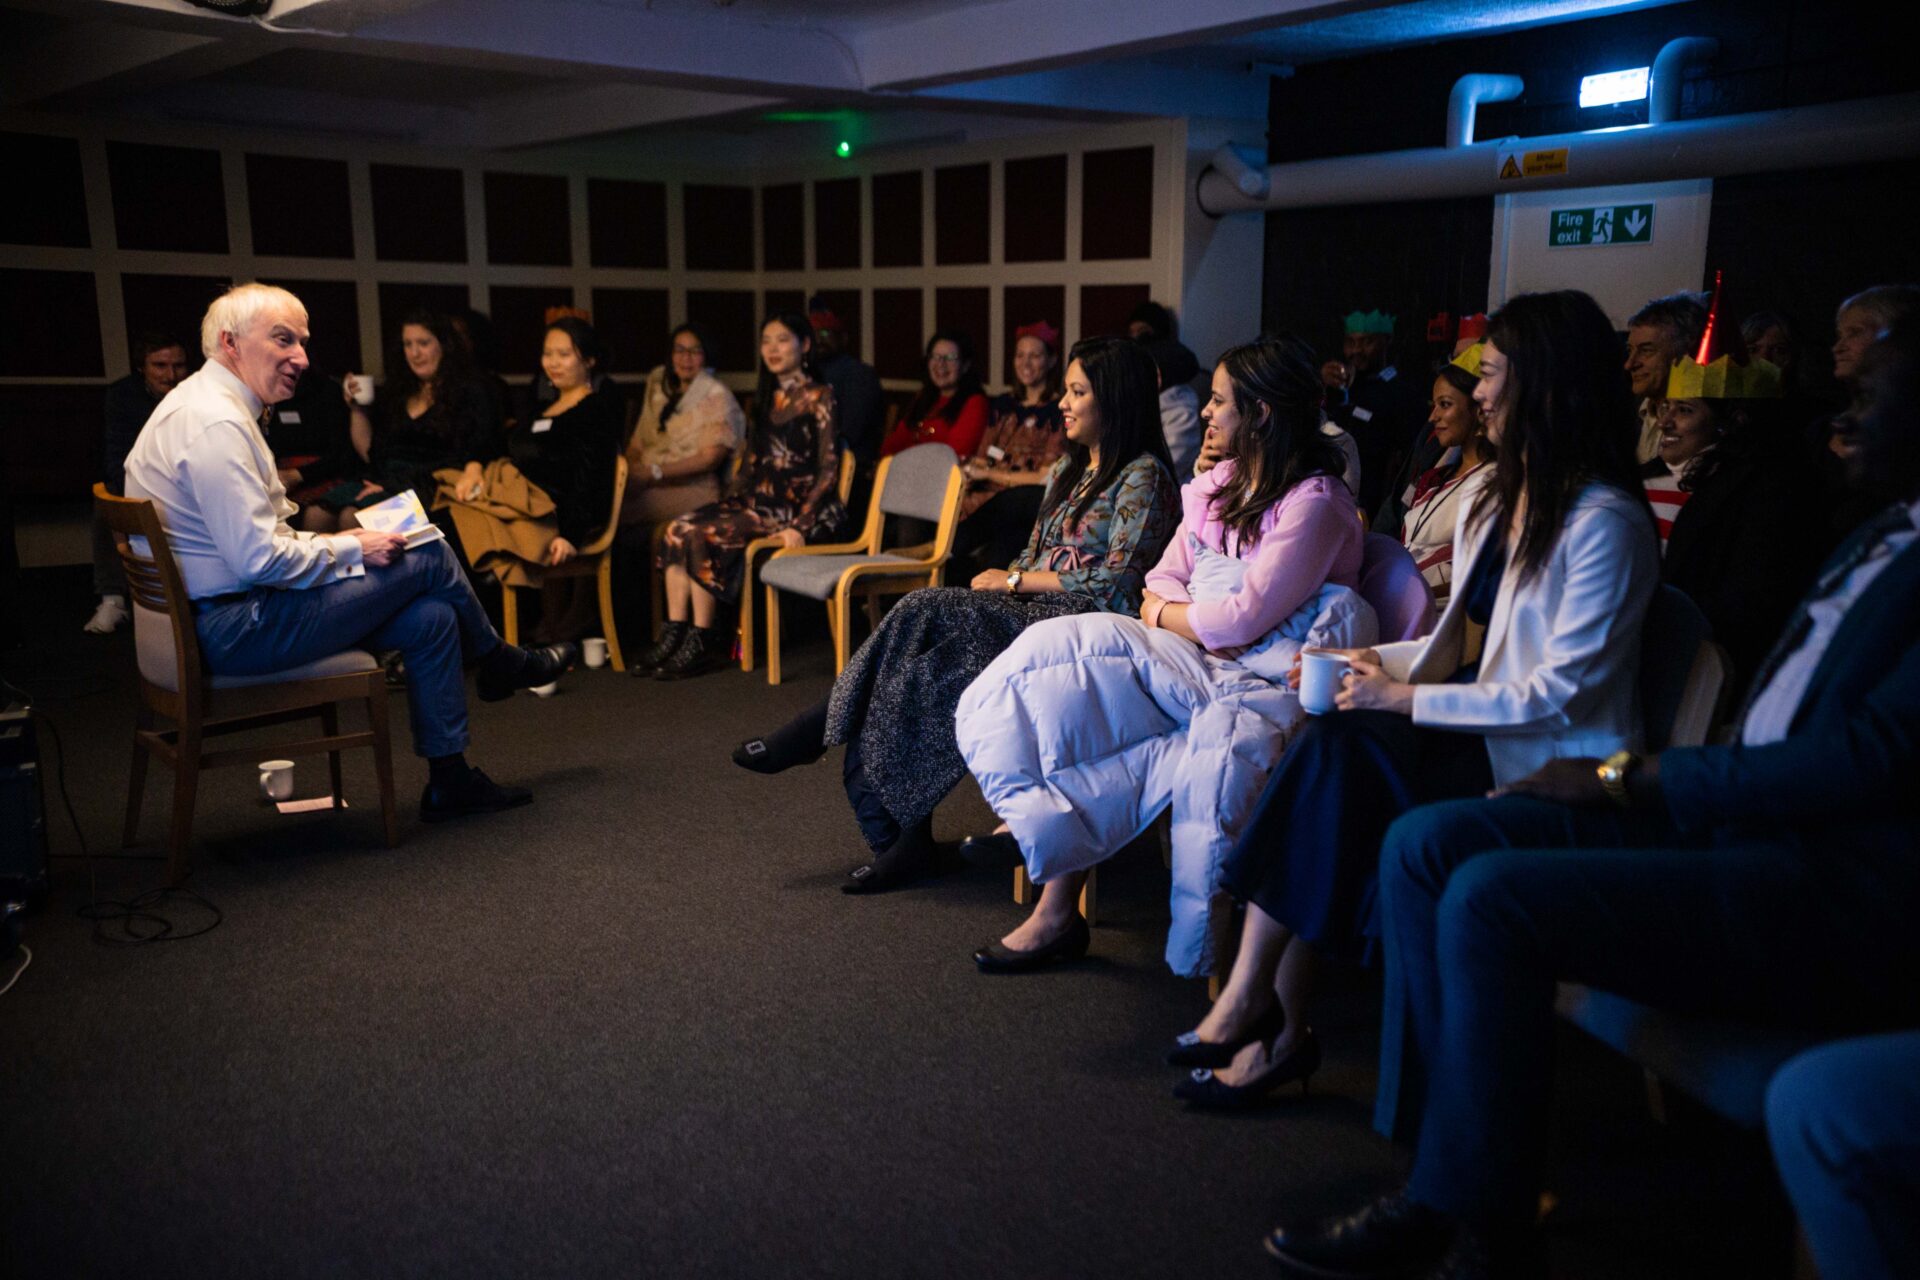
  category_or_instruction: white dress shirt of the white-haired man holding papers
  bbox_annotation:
[127,361,367,601]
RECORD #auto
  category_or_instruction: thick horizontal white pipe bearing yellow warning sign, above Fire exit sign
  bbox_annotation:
[1194,94,1920,217]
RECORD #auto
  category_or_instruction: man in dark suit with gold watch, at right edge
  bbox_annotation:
[1267,324,1920,1276]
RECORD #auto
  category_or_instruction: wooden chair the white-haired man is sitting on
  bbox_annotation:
[94,484,399,885]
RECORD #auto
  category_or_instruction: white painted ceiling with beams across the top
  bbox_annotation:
[0,0,1670,150]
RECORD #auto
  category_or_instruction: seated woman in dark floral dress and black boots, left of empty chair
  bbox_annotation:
[639,313,847,679]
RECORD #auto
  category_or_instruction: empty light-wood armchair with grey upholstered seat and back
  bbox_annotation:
[760,445,966,685]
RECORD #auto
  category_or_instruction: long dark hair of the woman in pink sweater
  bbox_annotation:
[1208,334,1346,553]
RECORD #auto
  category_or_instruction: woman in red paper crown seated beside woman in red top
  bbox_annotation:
[954,320,1068,568]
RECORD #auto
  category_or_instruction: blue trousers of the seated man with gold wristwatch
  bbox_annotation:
[1377,796,1920,1224]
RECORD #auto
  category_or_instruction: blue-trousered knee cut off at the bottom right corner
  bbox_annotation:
[1766,1031,1920,1280]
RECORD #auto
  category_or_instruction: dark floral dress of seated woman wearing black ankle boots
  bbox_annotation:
[659,380,847,601]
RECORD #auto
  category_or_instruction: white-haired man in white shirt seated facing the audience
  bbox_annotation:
[127,284,574,821]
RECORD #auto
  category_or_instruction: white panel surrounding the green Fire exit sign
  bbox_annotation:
[1486,178,1713,330]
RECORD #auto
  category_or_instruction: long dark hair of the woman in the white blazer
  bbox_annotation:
[1473,290,1651,580]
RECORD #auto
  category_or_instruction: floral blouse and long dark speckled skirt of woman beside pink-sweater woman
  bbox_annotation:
[826,453,1181,848]
